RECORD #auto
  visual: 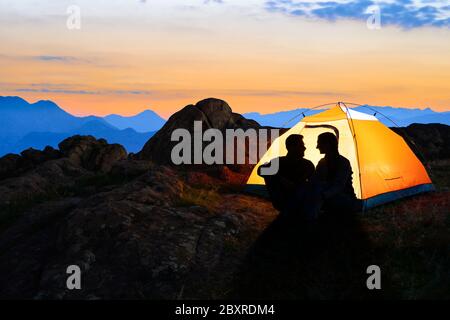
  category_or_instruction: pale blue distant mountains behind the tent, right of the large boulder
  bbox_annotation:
[243,105,450,128]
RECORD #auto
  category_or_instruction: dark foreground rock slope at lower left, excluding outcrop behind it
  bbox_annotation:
[0,167,275,299]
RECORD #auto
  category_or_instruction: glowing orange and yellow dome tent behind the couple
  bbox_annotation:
[247,103,434,209]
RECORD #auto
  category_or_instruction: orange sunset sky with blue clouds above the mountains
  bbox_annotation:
[0,0,450,117]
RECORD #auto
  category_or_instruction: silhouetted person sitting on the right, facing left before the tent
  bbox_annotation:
[314,132,361,213]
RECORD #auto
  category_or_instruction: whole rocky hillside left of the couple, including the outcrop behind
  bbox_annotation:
[0,131,275,299]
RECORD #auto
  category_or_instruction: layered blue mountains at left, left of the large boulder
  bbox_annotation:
[0,96,164,156]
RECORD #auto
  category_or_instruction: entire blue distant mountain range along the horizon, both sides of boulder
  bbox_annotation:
[0,96,450,157]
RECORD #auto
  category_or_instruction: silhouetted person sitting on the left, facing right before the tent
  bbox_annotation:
[258,134,314,213]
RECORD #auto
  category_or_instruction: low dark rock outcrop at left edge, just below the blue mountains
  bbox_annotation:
[0,136,127,208]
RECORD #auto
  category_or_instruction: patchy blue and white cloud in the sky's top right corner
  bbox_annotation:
[265,0,450,29]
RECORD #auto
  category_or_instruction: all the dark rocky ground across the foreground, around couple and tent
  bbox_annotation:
[0,101,450,299]
